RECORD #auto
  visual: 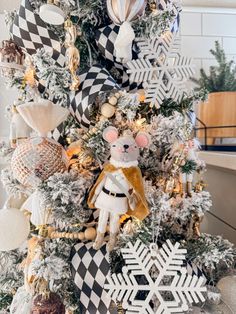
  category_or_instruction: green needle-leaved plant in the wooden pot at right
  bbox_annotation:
[192,41,236,93]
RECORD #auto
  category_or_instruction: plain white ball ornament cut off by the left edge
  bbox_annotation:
[0,208,30,251]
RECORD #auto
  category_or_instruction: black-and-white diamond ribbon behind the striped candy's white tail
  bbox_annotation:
[95,24,138,91]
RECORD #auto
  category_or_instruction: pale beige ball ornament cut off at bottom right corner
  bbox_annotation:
[216,275,236,311]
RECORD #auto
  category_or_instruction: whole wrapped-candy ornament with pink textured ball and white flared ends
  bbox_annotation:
[11,99,69,226]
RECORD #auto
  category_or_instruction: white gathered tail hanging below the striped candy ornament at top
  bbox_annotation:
[114,21,135,63]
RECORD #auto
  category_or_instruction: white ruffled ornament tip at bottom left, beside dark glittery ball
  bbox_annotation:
[10,286,33,314]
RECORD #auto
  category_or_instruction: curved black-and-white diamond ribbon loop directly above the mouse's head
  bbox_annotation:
[70,65,120,129]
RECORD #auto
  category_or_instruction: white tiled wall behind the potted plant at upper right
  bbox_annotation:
[181,6,236,73]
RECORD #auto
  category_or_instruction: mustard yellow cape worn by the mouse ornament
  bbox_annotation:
[88,164,149,220]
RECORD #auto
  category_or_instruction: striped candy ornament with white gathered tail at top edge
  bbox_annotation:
[107,0,146,63]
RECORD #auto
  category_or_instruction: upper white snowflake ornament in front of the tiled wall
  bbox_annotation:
[127,32,194,107]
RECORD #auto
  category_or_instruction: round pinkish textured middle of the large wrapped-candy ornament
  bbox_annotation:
[11,138,68,187]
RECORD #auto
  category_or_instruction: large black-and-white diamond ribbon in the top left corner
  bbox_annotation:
[11,0,66,67]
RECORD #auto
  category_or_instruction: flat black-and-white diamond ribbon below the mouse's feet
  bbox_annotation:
[71,242,117,314]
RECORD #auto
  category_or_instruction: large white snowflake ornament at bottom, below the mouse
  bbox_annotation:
[105,240,206,314]
